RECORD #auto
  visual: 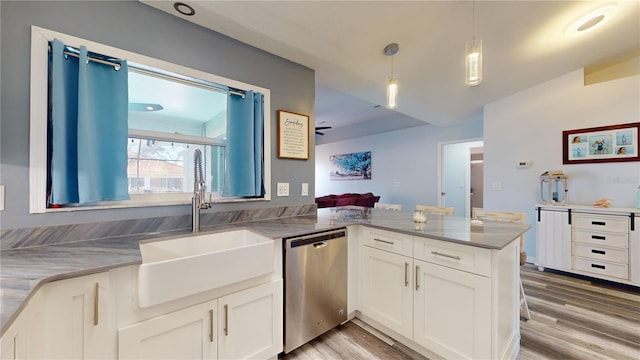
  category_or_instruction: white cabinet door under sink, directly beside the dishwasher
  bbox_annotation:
[218,280,283,359]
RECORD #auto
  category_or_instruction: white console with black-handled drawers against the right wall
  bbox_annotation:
[536,204,640,286]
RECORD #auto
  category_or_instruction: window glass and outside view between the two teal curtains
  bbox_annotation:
[127,65,227,194]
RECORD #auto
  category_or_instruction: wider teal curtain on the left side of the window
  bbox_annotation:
[49,40,129,204]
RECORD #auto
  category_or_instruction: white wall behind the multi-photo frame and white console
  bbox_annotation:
[484,70,640,259]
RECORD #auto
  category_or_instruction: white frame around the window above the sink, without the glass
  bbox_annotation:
[29,26,272,214]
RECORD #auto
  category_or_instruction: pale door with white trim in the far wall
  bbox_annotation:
[439,140,484,217]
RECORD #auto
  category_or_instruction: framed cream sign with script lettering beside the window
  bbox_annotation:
[278,110,309,160]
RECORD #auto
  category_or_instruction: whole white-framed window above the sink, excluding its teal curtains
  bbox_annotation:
[30,26,271,213]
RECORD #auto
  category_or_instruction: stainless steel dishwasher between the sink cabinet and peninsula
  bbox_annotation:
[283,228,348,353]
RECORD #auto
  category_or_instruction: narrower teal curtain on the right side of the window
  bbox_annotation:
[223,91,265,197]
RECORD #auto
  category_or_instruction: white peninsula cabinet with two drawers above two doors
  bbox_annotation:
[359,231,520,359]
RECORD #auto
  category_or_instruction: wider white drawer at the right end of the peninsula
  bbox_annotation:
[414,237,491,277]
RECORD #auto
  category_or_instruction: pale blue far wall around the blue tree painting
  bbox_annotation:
[315,114,482,211]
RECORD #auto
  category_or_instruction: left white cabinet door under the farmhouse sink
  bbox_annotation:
[118,300,218,359]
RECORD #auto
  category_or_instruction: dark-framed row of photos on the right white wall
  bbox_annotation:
[562,123,640,164]
